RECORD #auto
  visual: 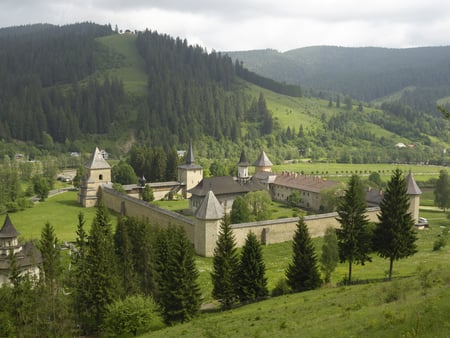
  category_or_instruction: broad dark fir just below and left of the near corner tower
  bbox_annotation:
[158,226,201,324]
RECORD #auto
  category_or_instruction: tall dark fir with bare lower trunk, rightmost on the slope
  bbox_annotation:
[374,169,417,280]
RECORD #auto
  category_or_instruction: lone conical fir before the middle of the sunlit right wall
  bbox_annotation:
[286,217,321,292]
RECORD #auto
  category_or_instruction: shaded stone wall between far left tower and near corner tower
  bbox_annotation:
[101,187,196,243]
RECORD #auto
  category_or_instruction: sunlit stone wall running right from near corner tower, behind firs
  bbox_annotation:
[231,207,380,247]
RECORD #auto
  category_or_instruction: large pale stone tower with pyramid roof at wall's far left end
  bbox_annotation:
[78,148,111,208]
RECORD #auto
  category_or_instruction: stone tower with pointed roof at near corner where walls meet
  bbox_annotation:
[194,190,225,257]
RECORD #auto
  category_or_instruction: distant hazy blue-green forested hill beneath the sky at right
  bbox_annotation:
[227,46,450,112]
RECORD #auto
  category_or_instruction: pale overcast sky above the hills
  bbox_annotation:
[0,0,450,51]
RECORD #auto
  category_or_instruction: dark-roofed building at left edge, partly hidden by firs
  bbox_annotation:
[0,215,42,286]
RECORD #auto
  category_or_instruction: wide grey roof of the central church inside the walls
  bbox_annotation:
[189,176,266,196]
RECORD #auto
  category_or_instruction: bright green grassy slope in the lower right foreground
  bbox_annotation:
[143,265,450,337]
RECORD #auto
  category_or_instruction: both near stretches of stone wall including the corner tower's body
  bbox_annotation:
[101,187,380,257]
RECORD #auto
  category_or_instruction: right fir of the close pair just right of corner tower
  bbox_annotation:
[238,232,269,302]
